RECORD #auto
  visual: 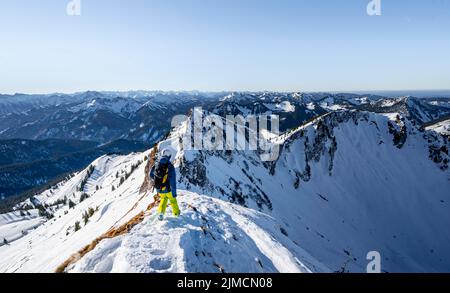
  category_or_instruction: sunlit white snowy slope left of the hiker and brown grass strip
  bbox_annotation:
[0,154,152,272]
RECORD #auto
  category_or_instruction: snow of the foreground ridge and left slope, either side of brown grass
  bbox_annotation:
[0,149,327,272]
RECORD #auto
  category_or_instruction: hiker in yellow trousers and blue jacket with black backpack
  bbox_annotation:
[150,150,180,221]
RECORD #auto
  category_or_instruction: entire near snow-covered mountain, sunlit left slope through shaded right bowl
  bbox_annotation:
[0,104,450,272]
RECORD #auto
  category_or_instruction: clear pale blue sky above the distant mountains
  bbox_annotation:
[0,0,450,93]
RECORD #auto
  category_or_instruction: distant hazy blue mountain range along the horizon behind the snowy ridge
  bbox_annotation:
[0,91,450,204]
